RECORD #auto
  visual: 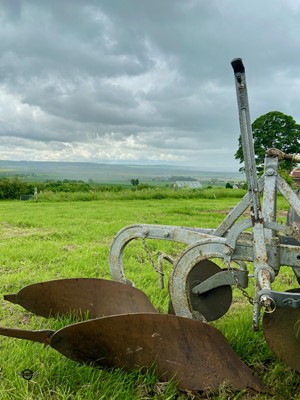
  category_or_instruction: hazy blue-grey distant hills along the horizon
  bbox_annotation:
[0,161,244,183]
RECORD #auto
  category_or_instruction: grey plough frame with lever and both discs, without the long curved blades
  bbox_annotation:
[109,58,300,356]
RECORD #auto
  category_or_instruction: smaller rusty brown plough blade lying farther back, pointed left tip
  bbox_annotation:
[4,278,156,318]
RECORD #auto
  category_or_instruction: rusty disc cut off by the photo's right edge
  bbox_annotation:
[263,288,300,372]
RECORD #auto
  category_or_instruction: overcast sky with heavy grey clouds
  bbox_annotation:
[0,0,300,171]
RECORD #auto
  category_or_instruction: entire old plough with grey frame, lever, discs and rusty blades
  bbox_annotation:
[0,58,300,392]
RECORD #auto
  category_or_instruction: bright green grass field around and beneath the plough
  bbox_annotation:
[0,193,300,400]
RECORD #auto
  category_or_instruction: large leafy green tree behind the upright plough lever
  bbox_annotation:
[235,111,300,173]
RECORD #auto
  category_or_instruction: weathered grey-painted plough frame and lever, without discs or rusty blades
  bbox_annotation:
[109,59,300,329]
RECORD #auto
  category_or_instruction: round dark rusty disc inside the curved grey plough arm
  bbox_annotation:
[187,260,232,322]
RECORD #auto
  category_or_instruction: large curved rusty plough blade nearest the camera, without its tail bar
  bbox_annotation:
[50,313,266,391]
